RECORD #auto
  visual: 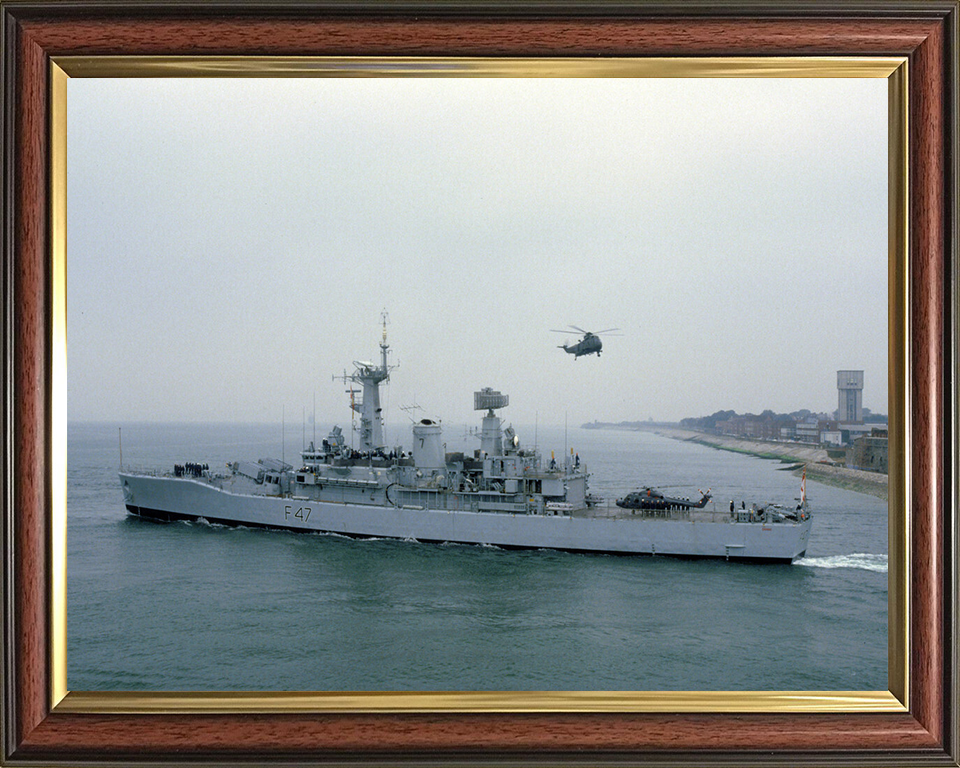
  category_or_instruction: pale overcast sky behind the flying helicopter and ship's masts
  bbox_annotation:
[68,78,887,425]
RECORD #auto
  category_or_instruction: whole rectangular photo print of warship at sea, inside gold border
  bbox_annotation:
[67,76,890,692]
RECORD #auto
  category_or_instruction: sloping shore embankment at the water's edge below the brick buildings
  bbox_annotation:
[640,425,887,499]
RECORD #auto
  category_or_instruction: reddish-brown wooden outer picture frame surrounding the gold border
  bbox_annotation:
[0,0,960,766]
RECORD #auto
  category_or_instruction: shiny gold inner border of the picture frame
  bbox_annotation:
[48,56,911,714]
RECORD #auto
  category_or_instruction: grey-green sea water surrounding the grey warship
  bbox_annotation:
[67,423,887,691]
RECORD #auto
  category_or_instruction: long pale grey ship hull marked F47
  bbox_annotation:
[120,473,811,563]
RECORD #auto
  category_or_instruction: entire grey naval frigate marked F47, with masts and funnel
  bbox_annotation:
[120,325,812,563]
